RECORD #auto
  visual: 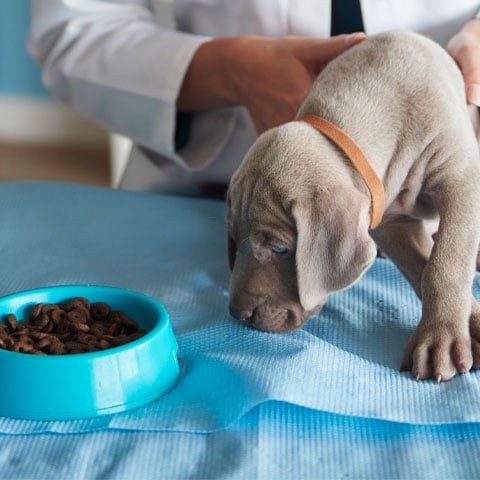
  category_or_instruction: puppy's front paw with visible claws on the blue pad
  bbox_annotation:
[401,323,473,383]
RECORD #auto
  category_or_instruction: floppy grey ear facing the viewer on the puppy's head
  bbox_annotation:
[292,189,377,311]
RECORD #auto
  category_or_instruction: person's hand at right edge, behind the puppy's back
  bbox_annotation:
[447,20,480,106]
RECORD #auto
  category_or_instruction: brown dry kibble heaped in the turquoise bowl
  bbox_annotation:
[0,297,146,355]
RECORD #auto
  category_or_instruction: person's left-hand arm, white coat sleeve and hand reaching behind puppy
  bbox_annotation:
[29,0,365,155]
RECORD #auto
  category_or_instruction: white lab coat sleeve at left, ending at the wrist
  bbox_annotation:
[29,0,209,161]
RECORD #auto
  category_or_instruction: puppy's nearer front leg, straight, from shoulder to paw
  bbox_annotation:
[403,178,480,382]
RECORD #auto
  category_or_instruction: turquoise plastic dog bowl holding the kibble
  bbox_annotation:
[0,285,179,420]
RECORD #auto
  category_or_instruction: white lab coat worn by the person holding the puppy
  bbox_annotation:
[29,0,480,193]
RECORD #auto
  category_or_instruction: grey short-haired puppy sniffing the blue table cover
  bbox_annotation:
[227,32,480,382]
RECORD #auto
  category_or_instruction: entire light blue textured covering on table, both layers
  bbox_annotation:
[0,182,480,480]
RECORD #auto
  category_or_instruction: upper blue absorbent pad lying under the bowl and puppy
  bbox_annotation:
[0,183,480,435]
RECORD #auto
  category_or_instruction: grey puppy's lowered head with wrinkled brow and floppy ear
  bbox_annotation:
[227,127,376,332]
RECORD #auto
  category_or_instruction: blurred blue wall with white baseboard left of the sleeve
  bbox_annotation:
[0,0,108,146]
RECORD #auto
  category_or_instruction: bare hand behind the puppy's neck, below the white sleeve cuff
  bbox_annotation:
[177,33,366,133]
